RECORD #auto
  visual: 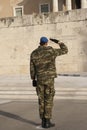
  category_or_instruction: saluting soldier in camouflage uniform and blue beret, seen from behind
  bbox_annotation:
[30,37,68,128]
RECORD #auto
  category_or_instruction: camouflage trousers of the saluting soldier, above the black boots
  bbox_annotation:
[36,78,55,119]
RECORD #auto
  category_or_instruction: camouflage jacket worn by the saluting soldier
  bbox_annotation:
[30,43,68,79]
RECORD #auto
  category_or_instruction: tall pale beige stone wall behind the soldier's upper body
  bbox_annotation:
[0,9,87,75]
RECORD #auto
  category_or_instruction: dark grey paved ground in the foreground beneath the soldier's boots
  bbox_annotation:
[0,100,87,130]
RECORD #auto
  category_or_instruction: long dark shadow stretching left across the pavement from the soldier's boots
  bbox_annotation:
[0,110,40,126]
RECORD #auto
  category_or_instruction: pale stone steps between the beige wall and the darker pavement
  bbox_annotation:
[0,73,87,103]
